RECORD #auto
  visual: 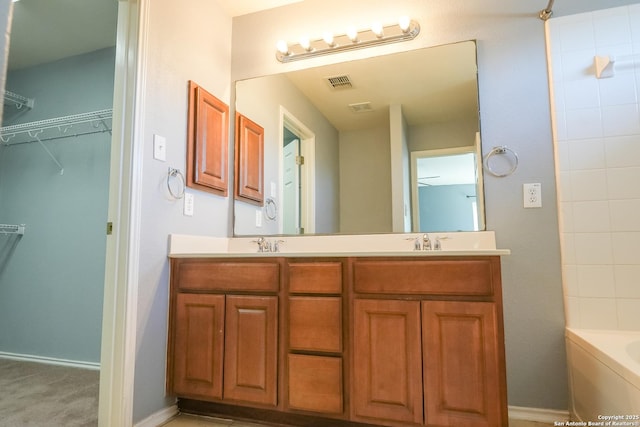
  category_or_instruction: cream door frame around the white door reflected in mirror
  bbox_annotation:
[278,105,316,234]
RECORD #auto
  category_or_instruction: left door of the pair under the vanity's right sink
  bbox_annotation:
[352,300,423,424]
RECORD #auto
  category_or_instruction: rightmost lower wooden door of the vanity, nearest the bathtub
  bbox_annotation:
[422,301,504,427]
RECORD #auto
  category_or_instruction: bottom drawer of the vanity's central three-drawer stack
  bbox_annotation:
[289,354,343,414]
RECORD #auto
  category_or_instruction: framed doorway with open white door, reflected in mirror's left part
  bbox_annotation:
[279,107,315,234]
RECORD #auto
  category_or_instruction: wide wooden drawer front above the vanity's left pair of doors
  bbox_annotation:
[176,260,280,292]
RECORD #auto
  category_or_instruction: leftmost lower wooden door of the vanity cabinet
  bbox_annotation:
[173,293,224,400]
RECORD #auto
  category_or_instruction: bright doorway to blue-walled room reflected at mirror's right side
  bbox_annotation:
[411,147,483,232]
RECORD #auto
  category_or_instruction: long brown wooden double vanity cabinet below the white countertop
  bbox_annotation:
[167,234,508,427]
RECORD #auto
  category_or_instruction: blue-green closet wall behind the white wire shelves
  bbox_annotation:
[0,48,115,364]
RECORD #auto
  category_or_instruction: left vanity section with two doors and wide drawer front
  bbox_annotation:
[168,259,280,407]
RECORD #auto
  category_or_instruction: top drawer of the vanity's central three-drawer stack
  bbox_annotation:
[289,262,342,294]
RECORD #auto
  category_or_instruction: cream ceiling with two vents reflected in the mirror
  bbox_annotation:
[286,41,478,133]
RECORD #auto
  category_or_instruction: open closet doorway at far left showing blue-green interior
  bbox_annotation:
[0,0,118,425]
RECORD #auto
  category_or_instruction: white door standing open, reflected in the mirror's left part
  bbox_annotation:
[282,139,300,234]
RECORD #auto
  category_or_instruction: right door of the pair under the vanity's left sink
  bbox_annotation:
[224,296,278,406]
